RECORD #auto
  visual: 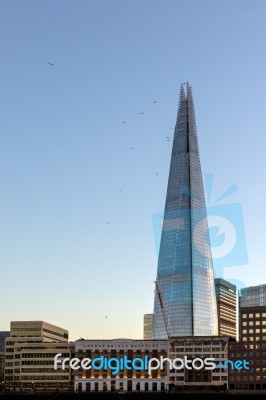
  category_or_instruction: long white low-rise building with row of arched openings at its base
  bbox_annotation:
[74,339,167,392]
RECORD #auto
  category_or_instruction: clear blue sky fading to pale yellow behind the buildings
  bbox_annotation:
[0,0,266,338]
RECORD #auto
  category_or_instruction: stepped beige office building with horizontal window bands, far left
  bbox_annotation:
[5,321,74,391]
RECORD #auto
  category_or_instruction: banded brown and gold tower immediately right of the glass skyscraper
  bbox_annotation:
[214,278,237,339]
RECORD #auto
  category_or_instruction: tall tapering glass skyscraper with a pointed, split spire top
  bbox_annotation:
[153,83,218,339]
